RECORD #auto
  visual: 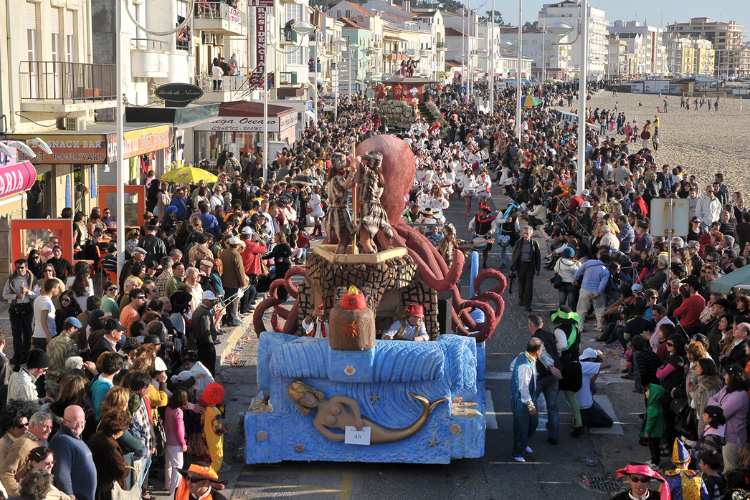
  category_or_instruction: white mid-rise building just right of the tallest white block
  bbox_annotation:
[609,20,668,77]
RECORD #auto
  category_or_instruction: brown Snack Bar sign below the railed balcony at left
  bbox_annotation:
[11,134,107,165]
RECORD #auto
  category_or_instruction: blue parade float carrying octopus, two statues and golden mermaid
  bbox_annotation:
[250,136,506,464]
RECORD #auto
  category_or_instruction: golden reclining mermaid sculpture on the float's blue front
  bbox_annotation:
[287,380,448,444]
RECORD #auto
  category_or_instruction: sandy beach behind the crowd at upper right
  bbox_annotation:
[590,91,750,196]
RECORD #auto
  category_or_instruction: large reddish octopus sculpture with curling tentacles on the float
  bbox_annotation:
[253,135,508,342]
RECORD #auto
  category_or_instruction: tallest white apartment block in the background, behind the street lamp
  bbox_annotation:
[539,0,608,78]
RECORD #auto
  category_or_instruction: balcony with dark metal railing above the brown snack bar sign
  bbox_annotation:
[19,61,116,113]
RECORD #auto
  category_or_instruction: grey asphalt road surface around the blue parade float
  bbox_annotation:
[209,188,648,500]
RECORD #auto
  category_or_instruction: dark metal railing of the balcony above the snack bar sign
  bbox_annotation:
[19,61,116,102]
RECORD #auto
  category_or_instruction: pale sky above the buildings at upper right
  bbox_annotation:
[476,0,750,39]
